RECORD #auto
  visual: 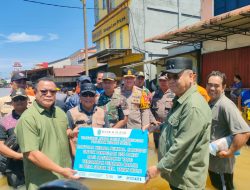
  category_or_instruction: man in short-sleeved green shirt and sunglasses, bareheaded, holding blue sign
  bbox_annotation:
[15,78,76,190]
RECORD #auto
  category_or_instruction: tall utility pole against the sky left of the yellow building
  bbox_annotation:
[81,0,89,76]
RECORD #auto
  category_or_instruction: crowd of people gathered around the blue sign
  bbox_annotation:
[0,57,250,190]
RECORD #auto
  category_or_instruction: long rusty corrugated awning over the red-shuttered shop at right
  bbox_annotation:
[145,5,250,45]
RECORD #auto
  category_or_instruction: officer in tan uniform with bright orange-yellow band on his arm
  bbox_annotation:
[116,68,150,129]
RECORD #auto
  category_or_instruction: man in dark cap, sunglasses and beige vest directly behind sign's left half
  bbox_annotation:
[67,83,109,155]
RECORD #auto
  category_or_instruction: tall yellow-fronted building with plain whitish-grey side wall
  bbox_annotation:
[92,0,200,80]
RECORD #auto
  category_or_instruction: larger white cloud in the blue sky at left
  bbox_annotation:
[6,32,43,43]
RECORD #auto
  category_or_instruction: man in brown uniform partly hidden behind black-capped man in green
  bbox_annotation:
[150,72,175,148]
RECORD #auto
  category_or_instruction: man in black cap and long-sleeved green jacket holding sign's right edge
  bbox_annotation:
[148,57,212,190]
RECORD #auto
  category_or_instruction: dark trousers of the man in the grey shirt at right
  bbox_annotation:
[208,171,234,190]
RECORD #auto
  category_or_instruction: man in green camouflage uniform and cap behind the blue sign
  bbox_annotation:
[97,72,129,128]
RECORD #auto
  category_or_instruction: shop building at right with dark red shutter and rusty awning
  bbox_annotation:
[145,0,250,88]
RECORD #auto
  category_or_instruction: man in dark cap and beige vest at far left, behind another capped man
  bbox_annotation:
[0,72,35,118]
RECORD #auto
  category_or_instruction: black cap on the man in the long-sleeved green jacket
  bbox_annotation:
[166,57,193,74]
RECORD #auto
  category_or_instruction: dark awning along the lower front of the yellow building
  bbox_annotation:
[89,49,131,63]
